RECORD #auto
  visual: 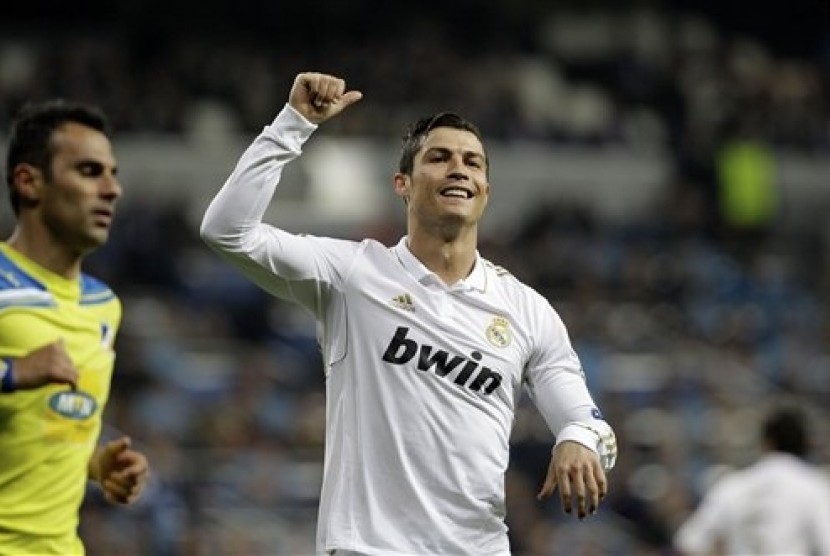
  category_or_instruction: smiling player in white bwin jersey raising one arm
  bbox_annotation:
[201,73,616,555]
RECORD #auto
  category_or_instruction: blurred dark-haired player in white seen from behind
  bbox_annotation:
[675,407,830,556]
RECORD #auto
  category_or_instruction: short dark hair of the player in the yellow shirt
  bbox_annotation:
[6,99,109,214]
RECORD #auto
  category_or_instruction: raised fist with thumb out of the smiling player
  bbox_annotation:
[288,72,363,124]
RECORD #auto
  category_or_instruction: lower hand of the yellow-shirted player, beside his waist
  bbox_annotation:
[90,436,150,504]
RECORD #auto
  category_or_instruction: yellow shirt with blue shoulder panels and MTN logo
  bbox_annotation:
[0,243,121,556]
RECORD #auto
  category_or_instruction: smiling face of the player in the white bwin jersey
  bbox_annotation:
[395,127,490,236]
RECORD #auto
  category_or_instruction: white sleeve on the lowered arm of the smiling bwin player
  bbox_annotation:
[526,298,617,471]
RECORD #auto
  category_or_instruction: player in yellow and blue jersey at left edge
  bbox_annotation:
[0,97,148,556]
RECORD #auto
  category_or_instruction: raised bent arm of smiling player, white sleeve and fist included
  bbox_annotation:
[200,73,362,309]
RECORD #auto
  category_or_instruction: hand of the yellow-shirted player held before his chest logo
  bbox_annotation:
[12,339,78,390]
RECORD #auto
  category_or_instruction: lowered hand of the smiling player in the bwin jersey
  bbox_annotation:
[537,441,608,519]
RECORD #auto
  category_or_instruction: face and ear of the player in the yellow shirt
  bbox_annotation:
[15,122,122,257]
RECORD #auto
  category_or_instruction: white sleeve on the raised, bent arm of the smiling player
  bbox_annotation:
[200,105,360,315]
